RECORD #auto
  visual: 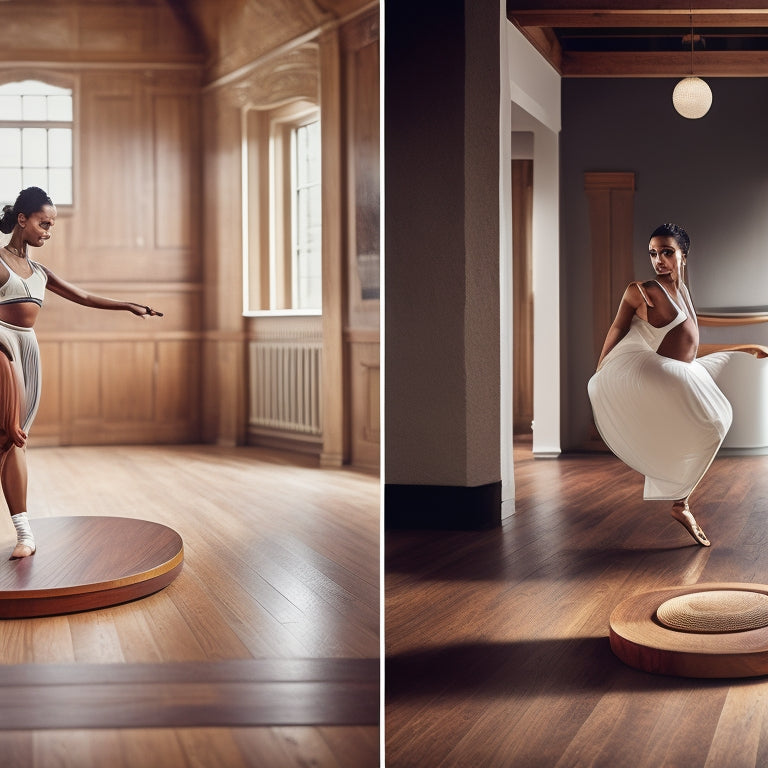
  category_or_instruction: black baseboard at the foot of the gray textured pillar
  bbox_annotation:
[384,481,501,531]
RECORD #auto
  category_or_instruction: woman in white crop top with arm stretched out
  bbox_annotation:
[0,187,162,559]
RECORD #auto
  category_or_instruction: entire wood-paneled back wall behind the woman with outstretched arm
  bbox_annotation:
[0,63,207,445]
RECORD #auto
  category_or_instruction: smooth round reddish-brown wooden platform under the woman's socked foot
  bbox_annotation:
[0,517,184,619]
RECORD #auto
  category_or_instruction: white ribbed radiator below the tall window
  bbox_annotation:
[249,341,322,435]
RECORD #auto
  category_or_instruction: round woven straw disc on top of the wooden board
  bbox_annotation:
[656,589,768,632]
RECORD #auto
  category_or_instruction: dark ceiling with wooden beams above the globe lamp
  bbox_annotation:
[507,0,768,77]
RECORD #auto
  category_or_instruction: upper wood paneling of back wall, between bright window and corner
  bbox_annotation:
[77,71,201,281]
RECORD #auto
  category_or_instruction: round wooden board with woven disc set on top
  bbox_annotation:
[610,582,768,677]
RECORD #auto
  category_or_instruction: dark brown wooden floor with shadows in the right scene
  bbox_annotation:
[385,438,768,768]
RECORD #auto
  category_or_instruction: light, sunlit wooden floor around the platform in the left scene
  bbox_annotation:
[0,446,380,768]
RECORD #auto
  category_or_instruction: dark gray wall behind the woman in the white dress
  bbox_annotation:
[560,78,768,449]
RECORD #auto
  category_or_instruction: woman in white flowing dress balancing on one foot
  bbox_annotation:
[587,224,732,547]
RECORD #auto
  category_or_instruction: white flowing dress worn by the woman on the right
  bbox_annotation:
[587,286,739,500]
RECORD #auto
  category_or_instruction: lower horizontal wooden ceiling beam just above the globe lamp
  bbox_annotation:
[553,51,768,77]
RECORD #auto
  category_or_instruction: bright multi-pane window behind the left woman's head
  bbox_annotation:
[0,80,73,205]
